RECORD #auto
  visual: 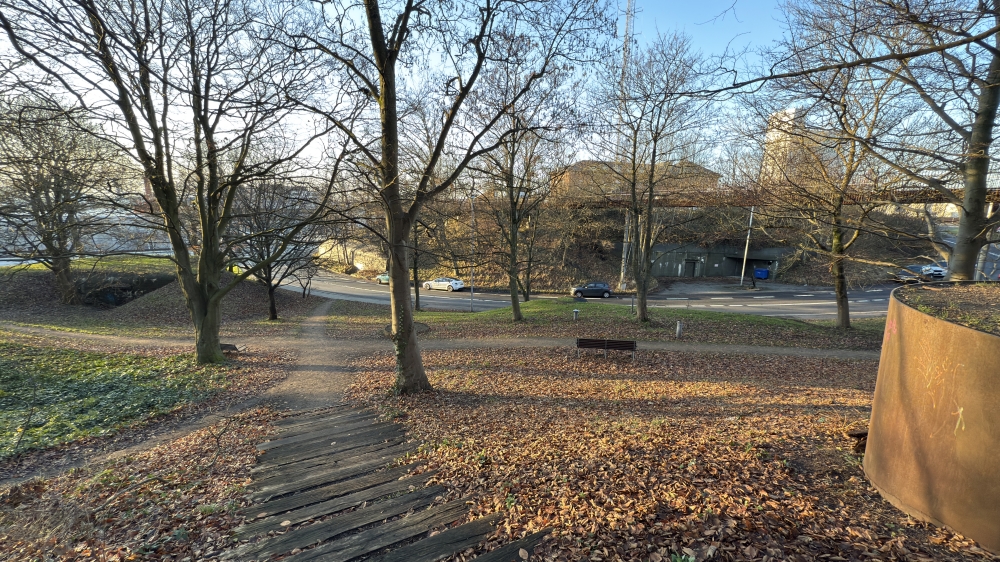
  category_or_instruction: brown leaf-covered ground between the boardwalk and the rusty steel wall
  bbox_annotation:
[349,349,989,561]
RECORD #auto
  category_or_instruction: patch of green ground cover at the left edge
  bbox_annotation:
[0,333,227,459]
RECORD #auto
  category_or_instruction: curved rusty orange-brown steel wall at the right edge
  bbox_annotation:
[864,292,1000,551]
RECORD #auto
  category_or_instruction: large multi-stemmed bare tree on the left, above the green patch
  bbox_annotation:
[0,0,350,362]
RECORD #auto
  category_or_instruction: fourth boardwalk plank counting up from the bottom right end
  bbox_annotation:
[234,486,448,560]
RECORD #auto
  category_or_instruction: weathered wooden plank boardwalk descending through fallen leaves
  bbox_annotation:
[223,406,547,562]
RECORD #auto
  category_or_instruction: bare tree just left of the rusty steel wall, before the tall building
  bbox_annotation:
[732,21,912,329]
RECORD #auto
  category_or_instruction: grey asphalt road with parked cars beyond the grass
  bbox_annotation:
[290,273,895,319]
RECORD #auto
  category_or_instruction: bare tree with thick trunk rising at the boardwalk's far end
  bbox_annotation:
[296,0,607,393]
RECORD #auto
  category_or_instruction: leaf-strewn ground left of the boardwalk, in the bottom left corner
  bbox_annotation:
[0,409,275,562]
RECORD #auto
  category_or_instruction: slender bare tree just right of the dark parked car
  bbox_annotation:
[593,34,712,322]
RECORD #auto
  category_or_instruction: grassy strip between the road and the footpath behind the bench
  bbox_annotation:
[329,297,885,349]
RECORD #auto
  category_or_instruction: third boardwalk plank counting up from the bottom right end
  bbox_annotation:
[284,500,468,562]
